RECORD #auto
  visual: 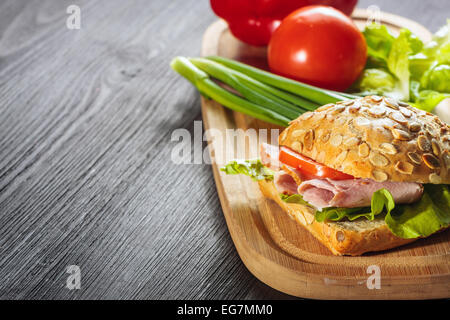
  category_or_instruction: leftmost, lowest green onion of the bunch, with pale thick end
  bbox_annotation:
[170,57,293,127]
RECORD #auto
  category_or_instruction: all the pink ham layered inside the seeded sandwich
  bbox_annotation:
[261,143,423,210]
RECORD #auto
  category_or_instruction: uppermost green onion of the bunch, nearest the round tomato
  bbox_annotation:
[207,56,348,105]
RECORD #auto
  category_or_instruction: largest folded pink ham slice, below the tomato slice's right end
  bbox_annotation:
[297,179,423,210]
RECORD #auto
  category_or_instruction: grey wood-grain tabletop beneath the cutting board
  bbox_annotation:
[0,0,450,299]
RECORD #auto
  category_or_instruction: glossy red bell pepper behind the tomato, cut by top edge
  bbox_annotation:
[211,0,358,46]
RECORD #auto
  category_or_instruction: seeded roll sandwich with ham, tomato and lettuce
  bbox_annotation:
[221,96,450,256]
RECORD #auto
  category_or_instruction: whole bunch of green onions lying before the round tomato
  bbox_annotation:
[171,57,356,127]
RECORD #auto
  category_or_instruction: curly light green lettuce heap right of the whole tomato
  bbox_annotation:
[350,20,450,111]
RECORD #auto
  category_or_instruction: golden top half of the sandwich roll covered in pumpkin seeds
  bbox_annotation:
[279,96,450,184]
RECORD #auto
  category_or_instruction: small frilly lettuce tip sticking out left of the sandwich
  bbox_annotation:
[220,159,274,181]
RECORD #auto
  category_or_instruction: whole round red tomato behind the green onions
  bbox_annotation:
[268,6,367,91]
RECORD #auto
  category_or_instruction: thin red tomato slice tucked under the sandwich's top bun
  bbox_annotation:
[279,146,354,180]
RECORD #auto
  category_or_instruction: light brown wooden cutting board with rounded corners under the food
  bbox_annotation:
[202,9,450,299]
